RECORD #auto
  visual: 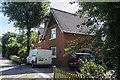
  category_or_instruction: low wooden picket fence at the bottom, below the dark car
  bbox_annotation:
[54,66,94,80]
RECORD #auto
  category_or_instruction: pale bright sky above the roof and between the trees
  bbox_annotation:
[0,0,78,36]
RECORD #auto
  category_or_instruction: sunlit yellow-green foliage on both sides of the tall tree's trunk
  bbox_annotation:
[2,31,37,58]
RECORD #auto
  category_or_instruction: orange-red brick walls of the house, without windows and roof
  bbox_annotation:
[35,16,92,66]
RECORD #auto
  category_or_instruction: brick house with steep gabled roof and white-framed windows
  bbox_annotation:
[33,8,93,66]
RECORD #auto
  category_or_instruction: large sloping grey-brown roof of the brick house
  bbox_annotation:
[51,8,93,35]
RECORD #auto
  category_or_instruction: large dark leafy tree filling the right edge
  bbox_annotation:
[68,0,120,78]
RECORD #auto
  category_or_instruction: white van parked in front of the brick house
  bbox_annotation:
[27,49,52,67]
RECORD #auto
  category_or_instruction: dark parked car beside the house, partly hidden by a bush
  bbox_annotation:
[68,53,95,70]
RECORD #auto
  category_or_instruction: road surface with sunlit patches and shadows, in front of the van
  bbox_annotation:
[0,57,53,80]
